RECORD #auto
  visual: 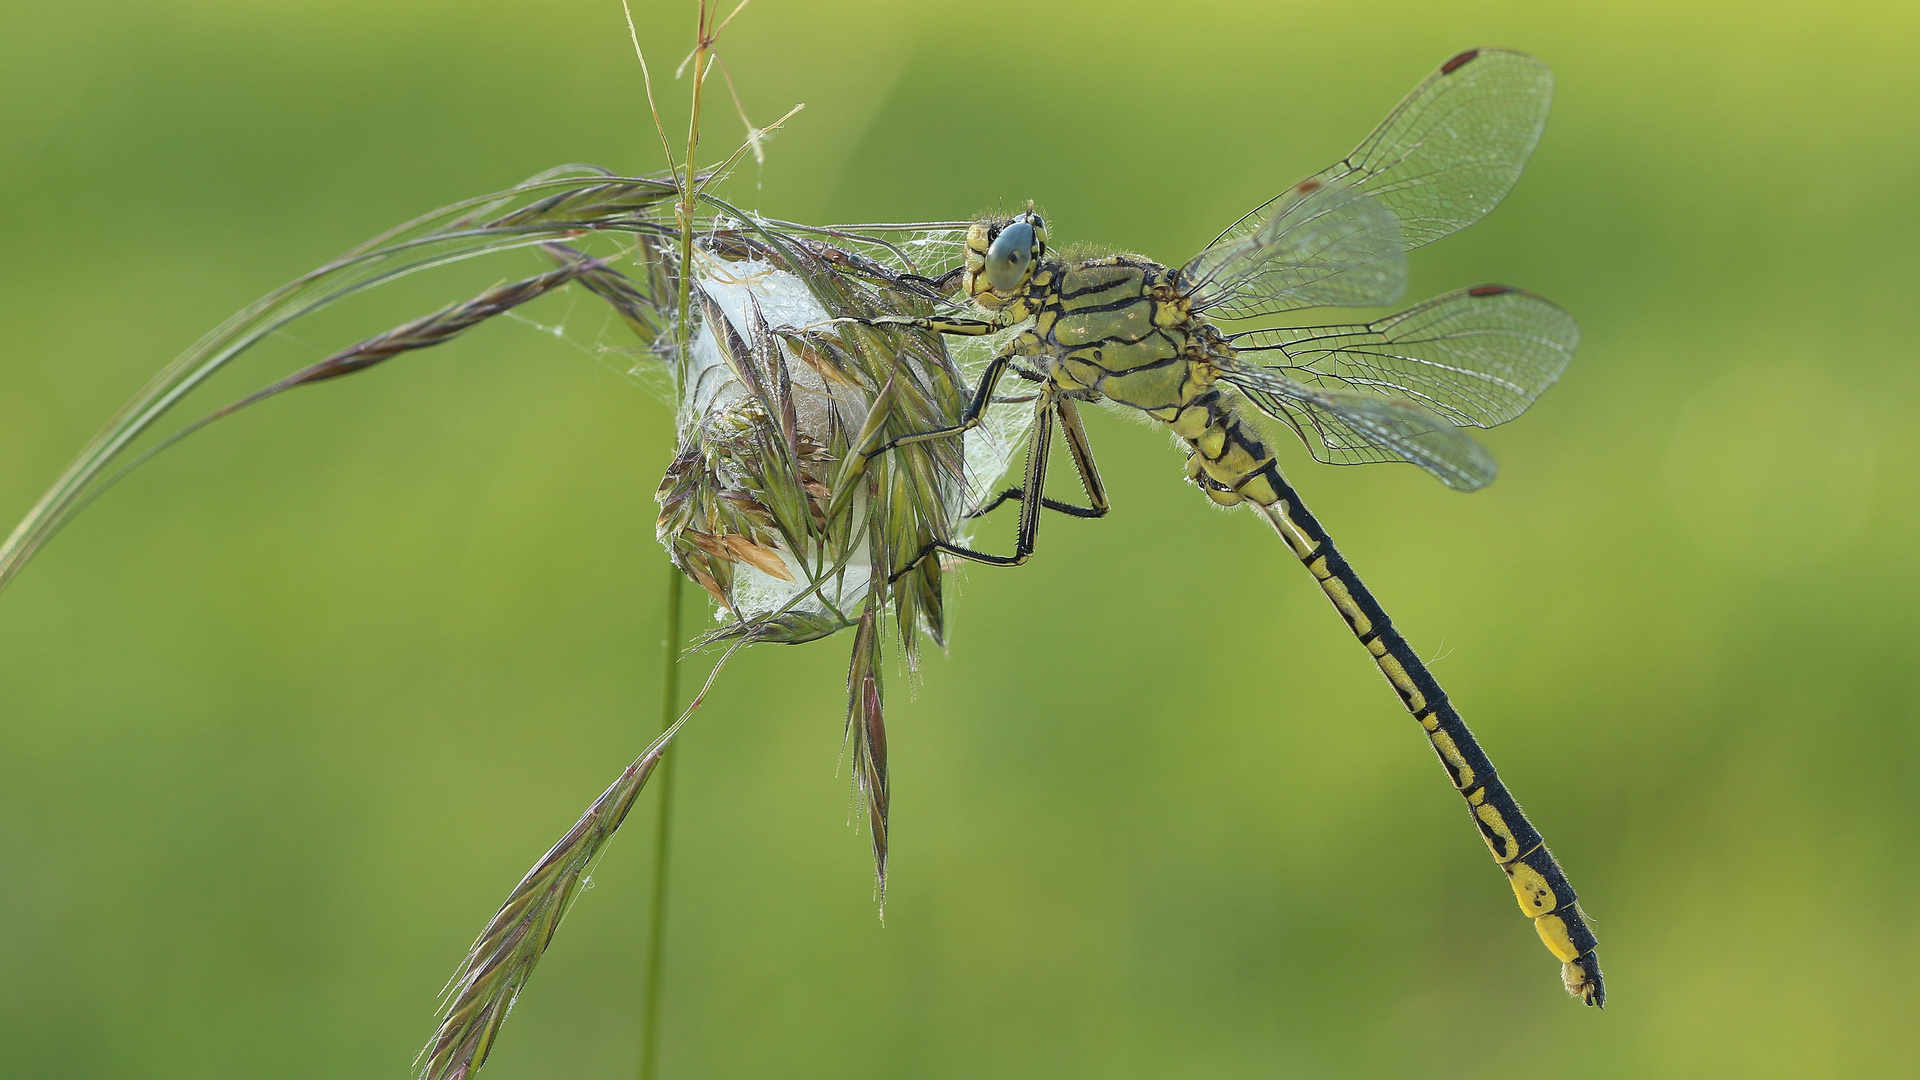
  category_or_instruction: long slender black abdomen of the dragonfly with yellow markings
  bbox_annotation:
[1254,463,1607,1005]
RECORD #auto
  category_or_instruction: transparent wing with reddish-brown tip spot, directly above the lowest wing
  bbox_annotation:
[1229,284,1580,427]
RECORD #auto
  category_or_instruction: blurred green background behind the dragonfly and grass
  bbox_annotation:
[0,0,1920,1080]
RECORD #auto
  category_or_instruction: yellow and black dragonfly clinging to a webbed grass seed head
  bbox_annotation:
[837,48,1605,1005]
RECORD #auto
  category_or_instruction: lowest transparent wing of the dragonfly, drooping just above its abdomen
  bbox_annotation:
[1221,361,1496,492]
